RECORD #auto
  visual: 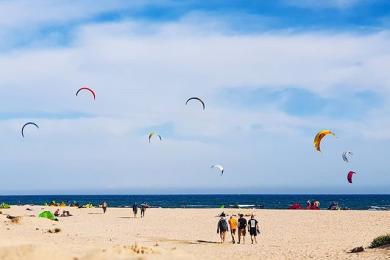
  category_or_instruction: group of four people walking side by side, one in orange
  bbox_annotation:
[217,213,260,244]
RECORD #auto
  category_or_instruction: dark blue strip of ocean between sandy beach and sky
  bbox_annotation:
[0,194,390,210]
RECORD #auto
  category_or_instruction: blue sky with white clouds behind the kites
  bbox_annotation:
[0,0,390,194]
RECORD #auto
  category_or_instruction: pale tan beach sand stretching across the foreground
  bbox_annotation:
[0,206,390,260]
